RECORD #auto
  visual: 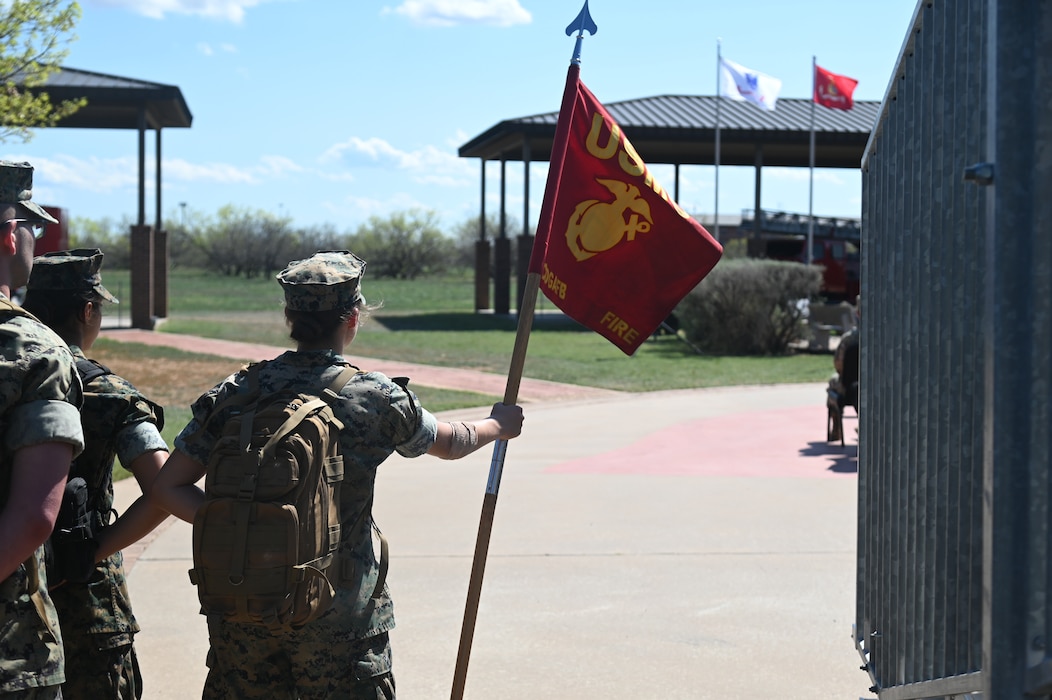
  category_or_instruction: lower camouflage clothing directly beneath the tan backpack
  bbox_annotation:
[201,616,395,700]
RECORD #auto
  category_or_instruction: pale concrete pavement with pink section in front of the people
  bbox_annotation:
[102,334,869,700]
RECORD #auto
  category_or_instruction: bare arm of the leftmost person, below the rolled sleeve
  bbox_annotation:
[0,442,73,580]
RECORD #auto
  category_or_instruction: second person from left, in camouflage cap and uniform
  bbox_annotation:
[25,248,168,700]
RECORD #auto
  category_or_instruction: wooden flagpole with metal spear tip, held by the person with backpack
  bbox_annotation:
[449,0,599,700]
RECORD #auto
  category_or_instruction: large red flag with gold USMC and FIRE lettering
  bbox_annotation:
[529,63,723,355]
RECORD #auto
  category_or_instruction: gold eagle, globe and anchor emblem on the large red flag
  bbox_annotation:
[566,178,653,262]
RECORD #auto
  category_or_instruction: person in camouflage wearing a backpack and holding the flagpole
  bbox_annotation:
[154,251,522,700]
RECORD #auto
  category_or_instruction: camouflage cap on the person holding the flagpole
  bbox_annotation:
[278,251,365,312]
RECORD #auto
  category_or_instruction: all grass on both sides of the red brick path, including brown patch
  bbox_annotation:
[100,269,832,478]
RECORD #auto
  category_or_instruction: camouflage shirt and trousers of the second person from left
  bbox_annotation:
[52,345,168,700]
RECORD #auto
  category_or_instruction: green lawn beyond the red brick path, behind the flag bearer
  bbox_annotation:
[105,269,832,392]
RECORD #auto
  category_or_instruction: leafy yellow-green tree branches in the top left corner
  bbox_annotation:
[0,0,85,142]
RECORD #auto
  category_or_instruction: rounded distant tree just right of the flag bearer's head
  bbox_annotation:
[350,209,457,280]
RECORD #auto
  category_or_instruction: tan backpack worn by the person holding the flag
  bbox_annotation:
[189,362,358,628]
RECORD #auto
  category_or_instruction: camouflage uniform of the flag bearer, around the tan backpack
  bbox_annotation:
[176,351,438,700]
